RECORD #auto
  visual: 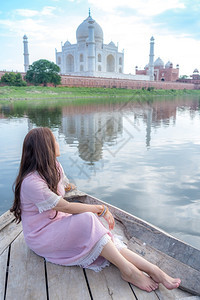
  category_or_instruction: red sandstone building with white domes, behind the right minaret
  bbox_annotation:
[135,57,179,81]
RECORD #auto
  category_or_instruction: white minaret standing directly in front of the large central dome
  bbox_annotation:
[88,10,95,72]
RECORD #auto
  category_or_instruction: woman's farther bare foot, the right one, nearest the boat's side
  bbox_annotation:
[149,266,181,290]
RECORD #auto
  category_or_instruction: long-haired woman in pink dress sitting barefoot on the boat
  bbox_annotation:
[11,128,181,292]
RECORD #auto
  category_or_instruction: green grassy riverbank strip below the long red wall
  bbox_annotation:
[0,86,200,102]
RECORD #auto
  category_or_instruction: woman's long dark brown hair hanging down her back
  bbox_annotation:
[10,127,60,223]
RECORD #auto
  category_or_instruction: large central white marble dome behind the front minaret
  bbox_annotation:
[76,16,103,42]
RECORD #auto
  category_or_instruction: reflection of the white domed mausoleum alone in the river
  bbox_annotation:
[59,111,122,164]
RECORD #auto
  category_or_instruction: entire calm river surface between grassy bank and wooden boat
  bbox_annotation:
[0,98,200,248]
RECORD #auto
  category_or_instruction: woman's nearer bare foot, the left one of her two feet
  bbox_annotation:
[121,270,158,292]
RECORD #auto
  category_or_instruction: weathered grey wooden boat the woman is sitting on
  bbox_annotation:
[0,191,200,300]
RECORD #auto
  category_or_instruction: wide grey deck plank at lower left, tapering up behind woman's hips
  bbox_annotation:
[6,233,47,300]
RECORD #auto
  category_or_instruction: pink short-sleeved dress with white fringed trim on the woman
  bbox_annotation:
[21,166,112,272]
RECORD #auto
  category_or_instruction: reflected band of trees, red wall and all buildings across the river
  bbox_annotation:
[0,98,200,156]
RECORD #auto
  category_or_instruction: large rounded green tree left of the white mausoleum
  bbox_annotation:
[25,59,61,86]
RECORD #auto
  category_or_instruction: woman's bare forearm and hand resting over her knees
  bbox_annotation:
[53,198,115,230]
